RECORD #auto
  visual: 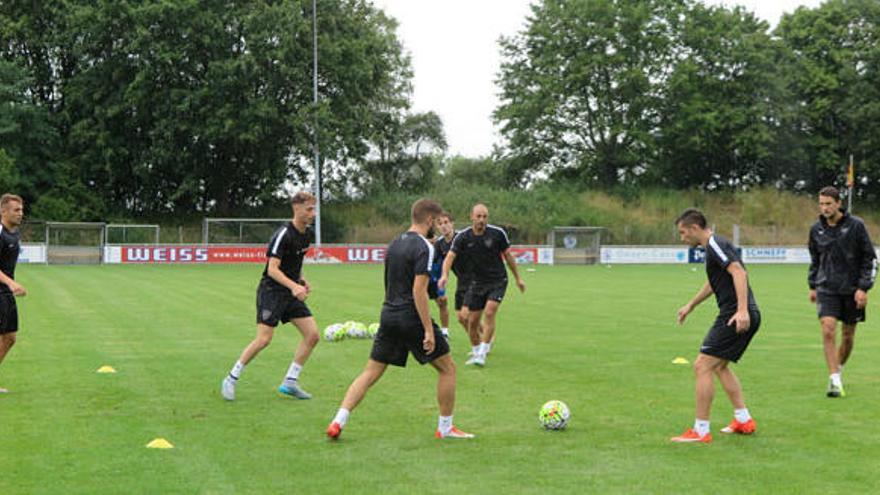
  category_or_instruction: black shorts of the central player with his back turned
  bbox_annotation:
[370,309,449,367]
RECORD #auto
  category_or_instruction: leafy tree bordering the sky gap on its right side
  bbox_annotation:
[495,0,688,186]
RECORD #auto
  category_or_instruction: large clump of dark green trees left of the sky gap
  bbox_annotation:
[0,0,411,215]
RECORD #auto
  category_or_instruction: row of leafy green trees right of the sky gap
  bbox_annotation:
[495,0,880,195]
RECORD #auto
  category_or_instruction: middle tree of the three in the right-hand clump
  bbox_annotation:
[651,3,782,188]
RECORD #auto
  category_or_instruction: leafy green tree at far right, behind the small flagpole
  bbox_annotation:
[776,0,880,195]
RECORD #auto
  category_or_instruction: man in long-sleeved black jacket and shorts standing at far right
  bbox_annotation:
[808,186,877,397]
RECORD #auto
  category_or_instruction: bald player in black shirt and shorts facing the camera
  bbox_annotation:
[438,204,526,366]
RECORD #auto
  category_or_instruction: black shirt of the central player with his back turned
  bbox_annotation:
[385,231,434,311]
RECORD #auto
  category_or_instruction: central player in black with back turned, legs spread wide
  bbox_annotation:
[327,199,473,439]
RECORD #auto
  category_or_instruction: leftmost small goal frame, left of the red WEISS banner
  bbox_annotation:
[46,222,106,265]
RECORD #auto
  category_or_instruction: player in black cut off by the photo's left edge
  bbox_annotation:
[0,194,27,394]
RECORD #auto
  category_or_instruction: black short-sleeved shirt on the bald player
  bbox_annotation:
[451,225,510,284]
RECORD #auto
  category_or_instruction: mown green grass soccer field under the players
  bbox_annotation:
[0,265,880,494]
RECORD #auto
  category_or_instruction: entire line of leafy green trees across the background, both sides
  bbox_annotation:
[0,0,880,220]
